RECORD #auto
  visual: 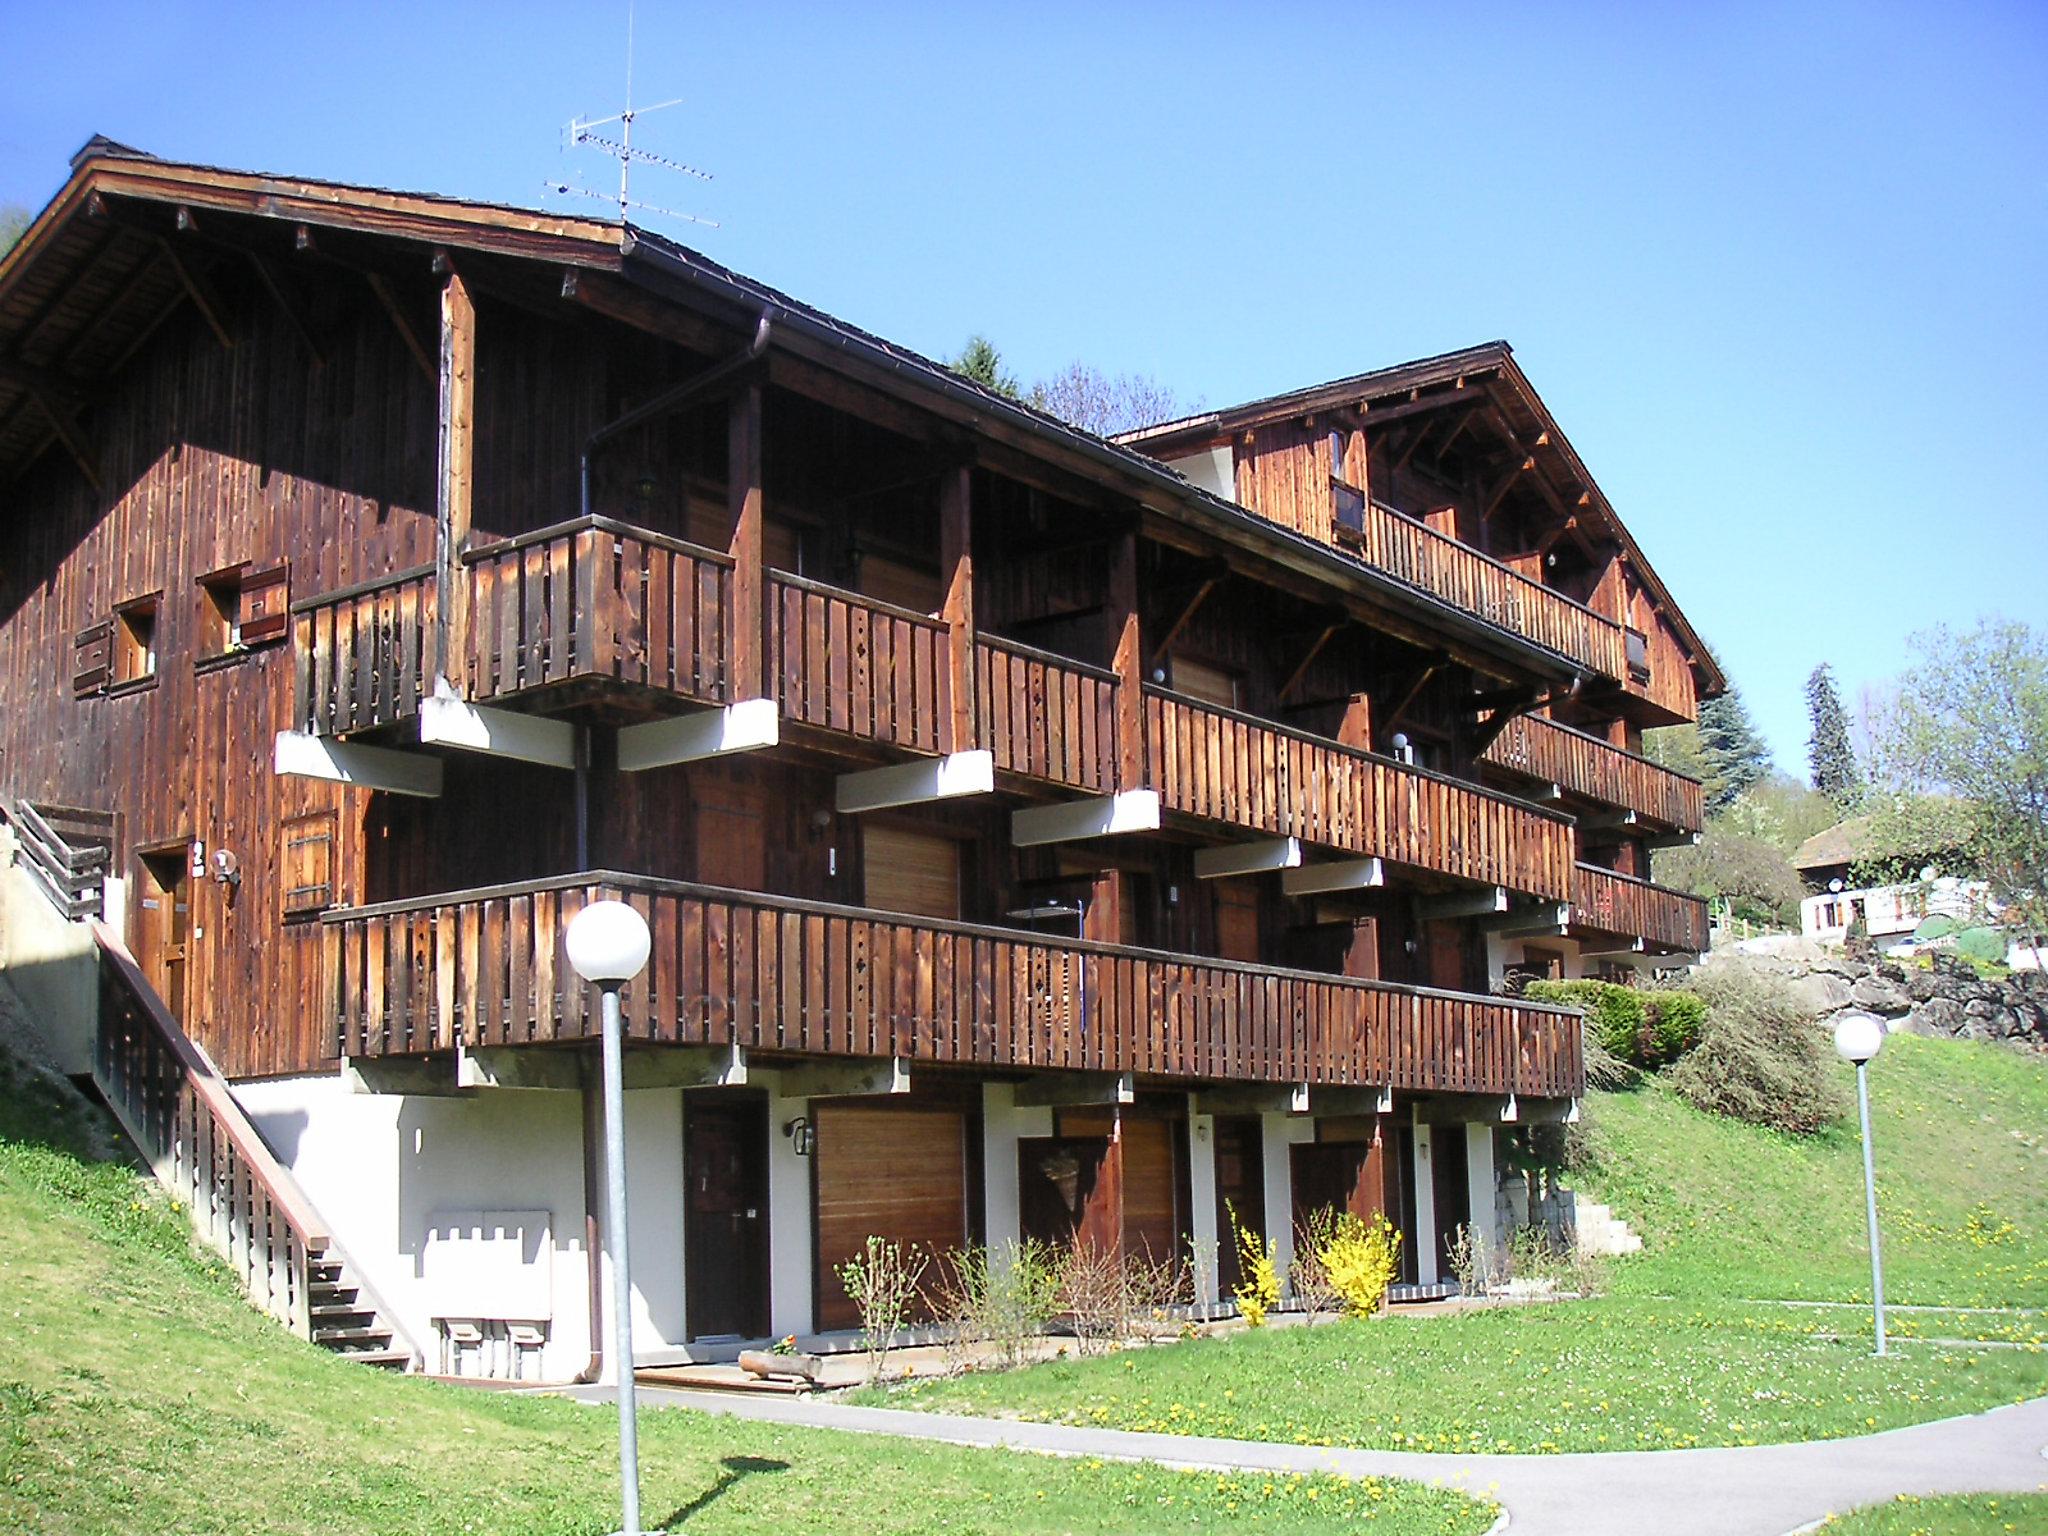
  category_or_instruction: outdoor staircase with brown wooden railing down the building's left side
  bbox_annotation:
[4,801,424,1370]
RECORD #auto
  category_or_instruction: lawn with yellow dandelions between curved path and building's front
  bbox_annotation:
[887,1298,2048,1452]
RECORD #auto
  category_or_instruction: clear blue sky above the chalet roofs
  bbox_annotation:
[0,0,2048,772]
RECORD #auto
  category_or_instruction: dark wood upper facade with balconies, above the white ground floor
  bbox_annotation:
[0,154,1712,1098]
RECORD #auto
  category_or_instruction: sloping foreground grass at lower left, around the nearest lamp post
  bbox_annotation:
[0,1083,1495,1536]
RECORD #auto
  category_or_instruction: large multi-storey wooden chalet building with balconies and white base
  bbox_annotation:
[0,139,1722,1378]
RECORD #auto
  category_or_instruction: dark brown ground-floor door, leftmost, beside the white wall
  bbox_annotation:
[682,1094,768,1339]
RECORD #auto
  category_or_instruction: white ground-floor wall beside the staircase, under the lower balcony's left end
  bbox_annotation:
[236,1075,684,1380]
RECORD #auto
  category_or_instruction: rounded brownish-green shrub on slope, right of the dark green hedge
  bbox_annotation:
[1669,963,1849,1135]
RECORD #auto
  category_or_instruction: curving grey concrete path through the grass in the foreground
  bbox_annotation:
[575,1386,2048,1536]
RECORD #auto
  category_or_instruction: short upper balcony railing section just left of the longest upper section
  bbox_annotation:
[975,635,1118,795]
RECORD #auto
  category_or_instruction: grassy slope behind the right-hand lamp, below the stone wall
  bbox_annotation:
[1577,1034,2048,1307]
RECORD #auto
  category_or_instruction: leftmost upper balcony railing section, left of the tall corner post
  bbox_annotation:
[291,565,436,735]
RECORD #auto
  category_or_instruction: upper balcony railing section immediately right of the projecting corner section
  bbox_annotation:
[768,571,952,752]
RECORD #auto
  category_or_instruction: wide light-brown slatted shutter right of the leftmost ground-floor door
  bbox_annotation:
[811,1102,967,1327]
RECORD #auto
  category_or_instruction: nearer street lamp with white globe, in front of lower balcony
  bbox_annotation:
[565,901,649,1536]
